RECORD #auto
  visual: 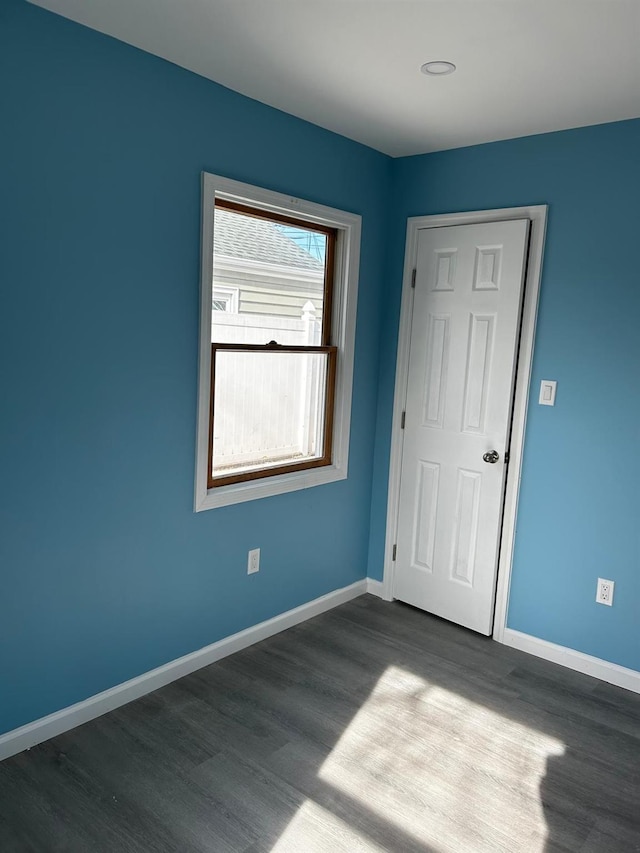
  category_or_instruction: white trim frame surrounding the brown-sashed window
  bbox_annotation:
[194,172,362,512]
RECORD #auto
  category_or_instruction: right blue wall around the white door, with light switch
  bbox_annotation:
[369,120,640,670]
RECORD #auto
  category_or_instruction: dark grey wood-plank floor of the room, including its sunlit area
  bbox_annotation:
[0,596,640,853]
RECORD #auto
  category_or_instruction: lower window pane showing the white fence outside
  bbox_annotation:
[212,350,329,477]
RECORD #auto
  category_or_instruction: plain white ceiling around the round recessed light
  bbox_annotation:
[32,0,640,156]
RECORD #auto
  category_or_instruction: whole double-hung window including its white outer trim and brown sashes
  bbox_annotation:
[195,173,360,510]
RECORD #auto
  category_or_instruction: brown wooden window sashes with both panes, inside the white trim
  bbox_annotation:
[207,199,337,488]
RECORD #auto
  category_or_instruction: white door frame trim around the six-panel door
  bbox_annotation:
[382,204,547,642]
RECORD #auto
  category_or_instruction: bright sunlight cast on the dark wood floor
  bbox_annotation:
[296,666,564,853]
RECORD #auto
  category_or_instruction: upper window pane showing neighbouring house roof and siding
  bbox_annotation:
[211,206,328,346]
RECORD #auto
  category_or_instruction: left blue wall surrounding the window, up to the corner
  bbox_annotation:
[0,0,390,732]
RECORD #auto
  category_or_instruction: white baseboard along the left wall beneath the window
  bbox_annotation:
[0,579,368,761]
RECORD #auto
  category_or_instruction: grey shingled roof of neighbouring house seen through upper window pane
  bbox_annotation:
[213,207,324,271]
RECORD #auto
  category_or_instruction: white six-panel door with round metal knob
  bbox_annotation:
[393,219,529,634]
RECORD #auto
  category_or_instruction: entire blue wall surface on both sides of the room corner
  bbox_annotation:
[0,0,640,732]
